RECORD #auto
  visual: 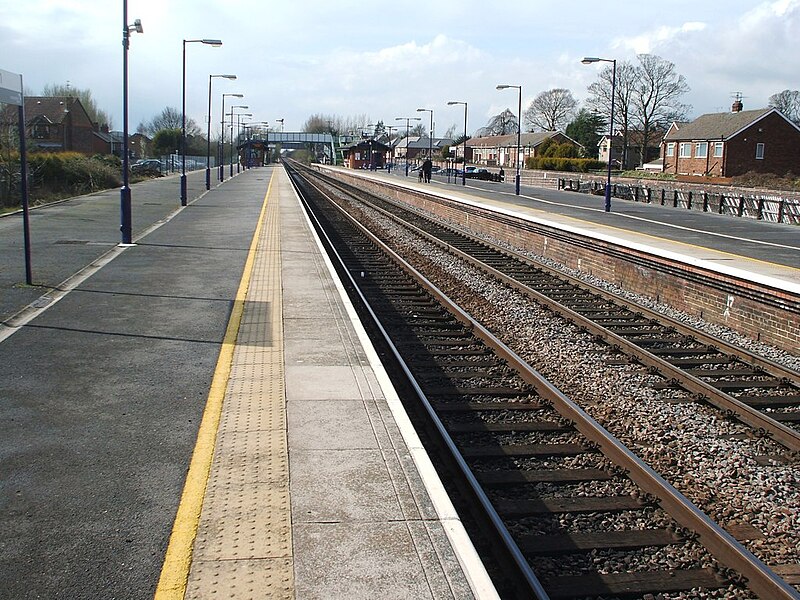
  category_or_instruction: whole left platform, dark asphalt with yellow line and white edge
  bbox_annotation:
[0,167,497,600]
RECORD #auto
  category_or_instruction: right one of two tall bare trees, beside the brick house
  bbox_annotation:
[633,54,691,164]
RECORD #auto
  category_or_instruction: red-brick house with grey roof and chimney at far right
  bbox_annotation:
[661,100,800,177]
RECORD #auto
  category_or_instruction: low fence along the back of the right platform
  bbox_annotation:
[558,178,800,225]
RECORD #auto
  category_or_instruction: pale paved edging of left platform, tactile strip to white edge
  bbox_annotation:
[162,169,493,599]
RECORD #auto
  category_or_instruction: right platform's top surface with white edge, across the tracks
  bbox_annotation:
[329,167,800,294]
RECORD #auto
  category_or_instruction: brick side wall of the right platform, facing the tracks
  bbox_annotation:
[322,166,800,354]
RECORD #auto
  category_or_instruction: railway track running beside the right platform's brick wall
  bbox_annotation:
[302,164,800,452]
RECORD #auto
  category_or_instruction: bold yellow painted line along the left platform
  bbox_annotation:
[154,171,275,600]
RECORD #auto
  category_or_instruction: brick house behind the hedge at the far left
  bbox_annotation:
[2,96,111,154]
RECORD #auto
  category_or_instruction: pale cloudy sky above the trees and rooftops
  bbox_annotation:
[0,0,800,133]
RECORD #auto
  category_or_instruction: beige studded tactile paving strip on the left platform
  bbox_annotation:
[186,171,294,600]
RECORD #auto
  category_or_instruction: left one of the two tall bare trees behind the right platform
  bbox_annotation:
[586,61,636,165]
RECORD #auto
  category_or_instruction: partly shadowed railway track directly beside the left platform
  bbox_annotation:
[284,162,799,598]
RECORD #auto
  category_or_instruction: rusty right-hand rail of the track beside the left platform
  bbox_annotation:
[284,163,800,600]
